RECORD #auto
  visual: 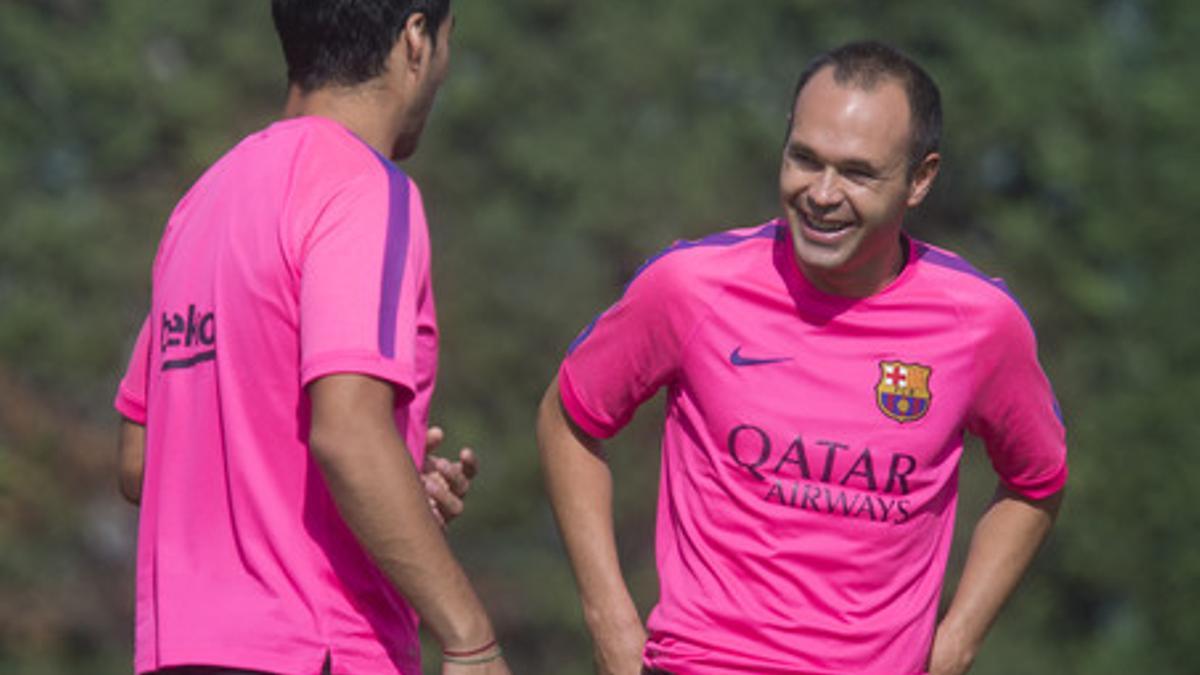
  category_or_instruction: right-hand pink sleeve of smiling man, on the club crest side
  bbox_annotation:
[967,297,1067,498]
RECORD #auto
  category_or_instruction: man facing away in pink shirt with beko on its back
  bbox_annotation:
[115,0,508,675]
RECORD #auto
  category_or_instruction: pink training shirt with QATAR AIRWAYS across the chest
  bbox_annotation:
[559,222,1067,675]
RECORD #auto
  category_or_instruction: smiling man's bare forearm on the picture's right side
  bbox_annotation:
[930,485,1062,675]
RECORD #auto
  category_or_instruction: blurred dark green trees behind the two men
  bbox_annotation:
[0,0,1200,675]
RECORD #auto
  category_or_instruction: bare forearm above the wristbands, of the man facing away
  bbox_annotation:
[310,376,493,650]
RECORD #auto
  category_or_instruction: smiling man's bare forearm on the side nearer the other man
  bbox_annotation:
[538,383,646,671]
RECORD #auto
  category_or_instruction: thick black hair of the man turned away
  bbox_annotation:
[271,0,450,91]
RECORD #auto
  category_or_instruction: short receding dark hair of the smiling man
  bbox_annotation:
[792,41,942,177]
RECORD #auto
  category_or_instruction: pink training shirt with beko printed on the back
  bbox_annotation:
[115,118,437,675]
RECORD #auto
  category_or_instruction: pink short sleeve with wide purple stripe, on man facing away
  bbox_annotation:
[300,160,428,395]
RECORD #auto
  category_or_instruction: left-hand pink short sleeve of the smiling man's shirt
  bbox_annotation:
[558,247,697,438]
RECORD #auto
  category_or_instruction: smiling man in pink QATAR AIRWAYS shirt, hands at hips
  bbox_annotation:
[538,43,1067,675]
